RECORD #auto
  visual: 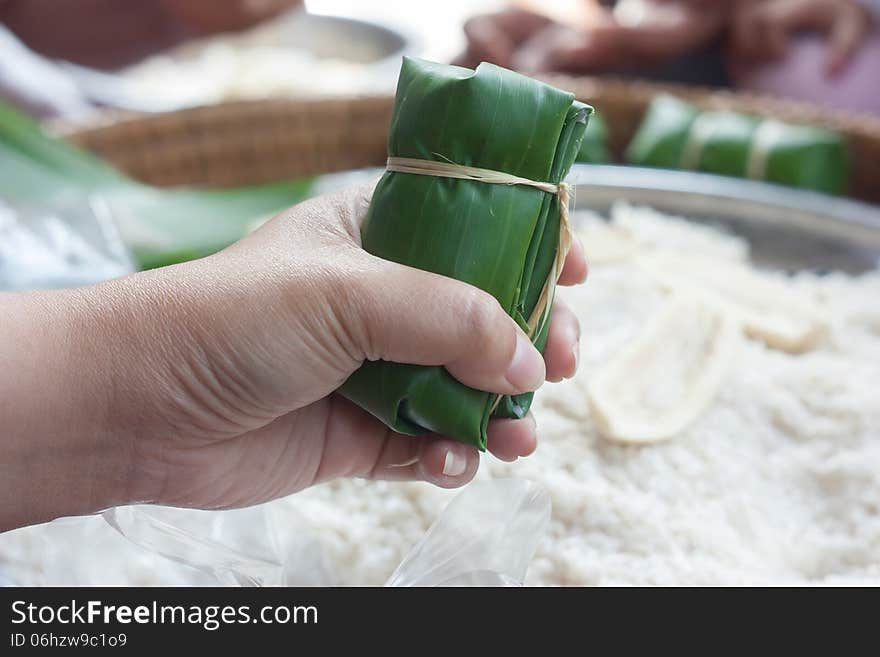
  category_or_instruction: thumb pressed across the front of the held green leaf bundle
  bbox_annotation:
[339,256,545,394]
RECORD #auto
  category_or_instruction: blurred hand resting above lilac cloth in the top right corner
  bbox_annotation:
[731,0,870,75]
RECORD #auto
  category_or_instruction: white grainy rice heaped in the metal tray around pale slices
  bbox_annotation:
[0,205,880,585]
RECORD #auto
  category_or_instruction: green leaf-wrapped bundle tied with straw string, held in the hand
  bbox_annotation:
[340,58,592,450]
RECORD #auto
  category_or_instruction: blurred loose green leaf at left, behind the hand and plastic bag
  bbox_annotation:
[0,102,311,269]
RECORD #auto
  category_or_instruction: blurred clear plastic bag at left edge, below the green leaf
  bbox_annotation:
[0,197,134,290]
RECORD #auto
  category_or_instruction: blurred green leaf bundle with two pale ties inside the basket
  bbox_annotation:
[627,96,849,194]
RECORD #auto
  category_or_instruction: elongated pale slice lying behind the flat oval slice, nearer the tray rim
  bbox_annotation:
[640,253,828,353]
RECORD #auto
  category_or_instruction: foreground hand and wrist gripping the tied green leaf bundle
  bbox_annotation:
[34,183,586,508]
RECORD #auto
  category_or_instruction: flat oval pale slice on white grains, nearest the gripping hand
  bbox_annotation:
[589,293,741,443]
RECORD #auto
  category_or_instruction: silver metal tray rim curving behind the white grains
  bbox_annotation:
[568,165,880,273]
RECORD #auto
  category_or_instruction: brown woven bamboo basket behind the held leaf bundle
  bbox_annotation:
[69,76,880,203]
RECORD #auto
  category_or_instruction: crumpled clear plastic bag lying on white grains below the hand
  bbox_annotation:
[104,479,550,586]
